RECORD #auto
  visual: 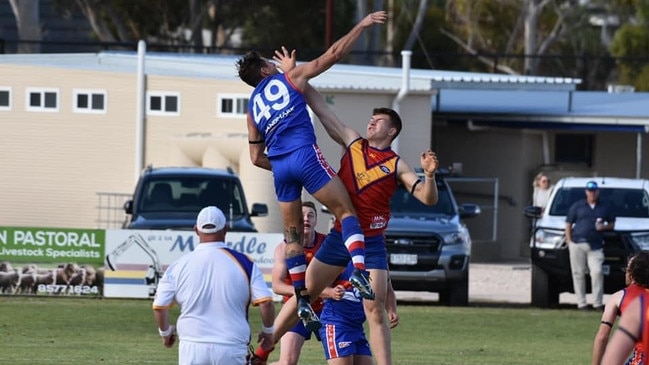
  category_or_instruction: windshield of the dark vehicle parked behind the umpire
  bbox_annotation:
[138,176,245,216]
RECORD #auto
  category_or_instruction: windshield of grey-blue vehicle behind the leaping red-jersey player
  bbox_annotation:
[390,181,456,215]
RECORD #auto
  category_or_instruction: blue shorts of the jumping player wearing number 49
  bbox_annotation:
[270,145,336,202]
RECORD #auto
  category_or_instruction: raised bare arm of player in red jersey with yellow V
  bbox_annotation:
[304,83,360,147]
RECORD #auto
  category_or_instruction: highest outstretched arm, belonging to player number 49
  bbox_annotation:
[288,11,388,90]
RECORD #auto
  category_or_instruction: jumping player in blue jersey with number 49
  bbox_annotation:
[236,11,387,331]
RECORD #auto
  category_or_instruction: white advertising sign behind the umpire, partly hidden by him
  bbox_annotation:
[104,230,283,298]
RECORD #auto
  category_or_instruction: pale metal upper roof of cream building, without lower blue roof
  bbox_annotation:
[0,51,581,92]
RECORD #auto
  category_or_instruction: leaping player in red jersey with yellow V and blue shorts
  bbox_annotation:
[251,48,438,365]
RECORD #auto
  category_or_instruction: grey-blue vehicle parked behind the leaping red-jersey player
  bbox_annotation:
[385,173,480,306]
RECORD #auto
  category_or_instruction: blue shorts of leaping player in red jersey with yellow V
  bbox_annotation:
[315,229,388,270]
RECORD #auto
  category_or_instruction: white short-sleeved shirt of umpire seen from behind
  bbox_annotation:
[153,242,272,345]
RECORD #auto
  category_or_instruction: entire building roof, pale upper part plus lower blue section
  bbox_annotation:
[0,51,649,131]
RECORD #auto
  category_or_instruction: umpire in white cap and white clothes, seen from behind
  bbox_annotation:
[153,206,275,365]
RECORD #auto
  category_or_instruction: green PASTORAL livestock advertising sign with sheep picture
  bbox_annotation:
[0,227,105,296]
